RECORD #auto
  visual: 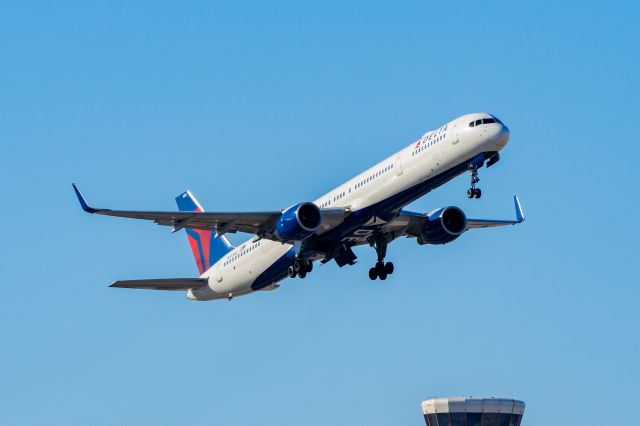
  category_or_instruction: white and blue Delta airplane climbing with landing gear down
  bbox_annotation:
[73,113,524,300]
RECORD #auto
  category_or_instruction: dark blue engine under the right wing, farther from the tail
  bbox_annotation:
[418,206,467,244]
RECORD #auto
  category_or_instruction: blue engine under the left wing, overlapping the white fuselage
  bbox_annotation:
[275,203,322,241]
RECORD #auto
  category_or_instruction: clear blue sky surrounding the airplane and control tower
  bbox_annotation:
[0,0,640,426]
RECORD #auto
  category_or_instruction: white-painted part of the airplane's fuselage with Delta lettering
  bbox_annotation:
[187,113,509,300]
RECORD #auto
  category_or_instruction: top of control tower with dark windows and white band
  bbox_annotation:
[422,397,524,426]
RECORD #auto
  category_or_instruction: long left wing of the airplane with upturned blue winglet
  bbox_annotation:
[73,184,348,239]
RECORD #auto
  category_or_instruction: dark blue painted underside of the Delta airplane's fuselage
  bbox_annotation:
[251,153,494,290]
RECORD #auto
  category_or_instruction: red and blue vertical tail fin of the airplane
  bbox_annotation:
[176,191,233,275]
